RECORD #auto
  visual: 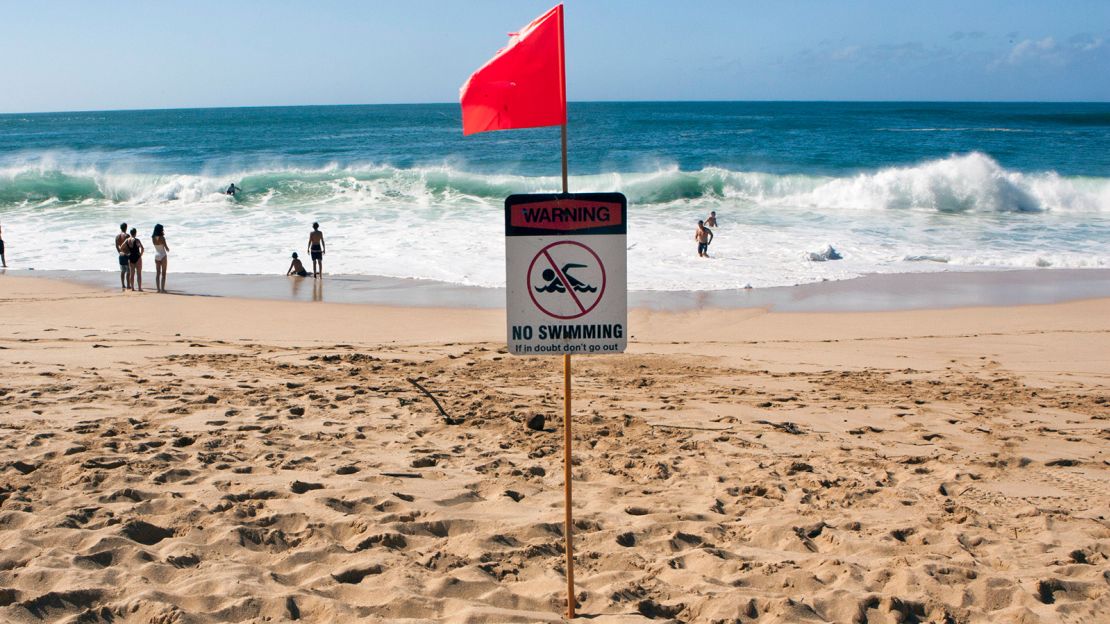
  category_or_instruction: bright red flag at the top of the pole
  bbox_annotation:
[458,4,566,134]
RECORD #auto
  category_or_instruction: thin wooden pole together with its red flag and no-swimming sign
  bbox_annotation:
[458,4,603,618]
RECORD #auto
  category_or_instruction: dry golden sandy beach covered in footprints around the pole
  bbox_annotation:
[0,275,1110,624]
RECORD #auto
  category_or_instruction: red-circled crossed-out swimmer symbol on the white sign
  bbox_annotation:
[527,241,605,320]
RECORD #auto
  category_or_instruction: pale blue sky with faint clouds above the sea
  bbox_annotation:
[0,0,1110,112]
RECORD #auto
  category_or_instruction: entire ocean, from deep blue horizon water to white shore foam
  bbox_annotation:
[0,102,1110,291]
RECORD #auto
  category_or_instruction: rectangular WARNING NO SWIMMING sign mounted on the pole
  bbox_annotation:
[505,193,628,355]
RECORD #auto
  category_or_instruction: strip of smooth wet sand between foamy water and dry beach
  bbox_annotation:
[9,264,1110,312]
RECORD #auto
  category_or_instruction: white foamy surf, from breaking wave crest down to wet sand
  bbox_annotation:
[0,152,1110,290]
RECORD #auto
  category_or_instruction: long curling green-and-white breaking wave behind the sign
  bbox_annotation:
[0,152,1110,213]
